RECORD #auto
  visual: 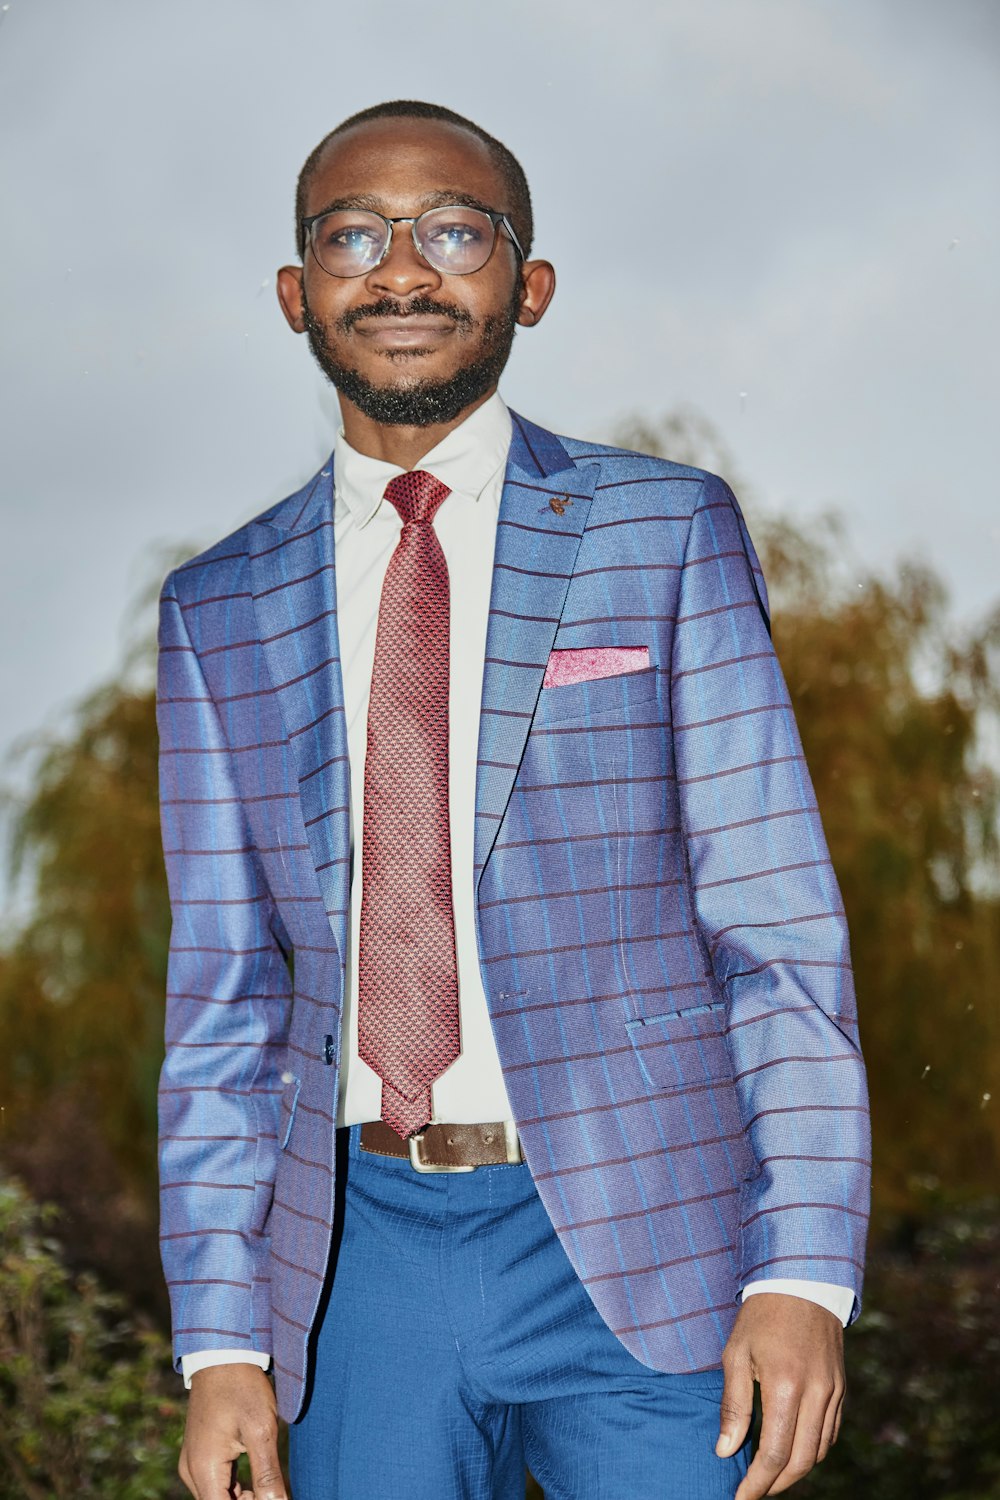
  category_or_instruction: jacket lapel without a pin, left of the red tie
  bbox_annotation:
[250,461,351,953]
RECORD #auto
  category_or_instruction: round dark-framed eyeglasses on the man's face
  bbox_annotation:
[301,203,525,276]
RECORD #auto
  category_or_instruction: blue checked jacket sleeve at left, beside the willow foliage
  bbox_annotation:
[156,575,291,1368]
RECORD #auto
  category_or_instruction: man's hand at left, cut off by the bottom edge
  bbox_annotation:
[177,1365,288,1500]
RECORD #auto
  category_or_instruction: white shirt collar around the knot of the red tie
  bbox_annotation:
[333,392,513,527]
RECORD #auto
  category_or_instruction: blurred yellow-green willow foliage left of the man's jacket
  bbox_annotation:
[0,684,169,1175]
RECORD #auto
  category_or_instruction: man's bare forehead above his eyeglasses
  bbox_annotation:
[306,119,510,215]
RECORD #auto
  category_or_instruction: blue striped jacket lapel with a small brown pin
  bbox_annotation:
[475,413,600,885]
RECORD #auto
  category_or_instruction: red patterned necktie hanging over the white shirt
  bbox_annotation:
[358,470,462,1139]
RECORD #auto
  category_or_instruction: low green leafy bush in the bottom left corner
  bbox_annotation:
[0,1178,183,1500]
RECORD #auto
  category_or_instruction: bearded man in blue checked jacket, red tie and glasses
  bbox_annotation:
[159,102,868,1500]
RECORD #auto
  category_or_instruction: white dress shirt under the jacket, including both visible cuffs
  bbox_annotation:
[181,395,855,1386]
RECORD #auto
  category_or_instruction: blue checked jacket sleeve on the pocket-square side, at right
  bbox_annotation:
[670,476,870,1316]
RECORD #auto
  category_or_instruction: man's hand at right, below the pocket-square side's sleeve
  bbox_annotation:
[715,1292,847,1500]
